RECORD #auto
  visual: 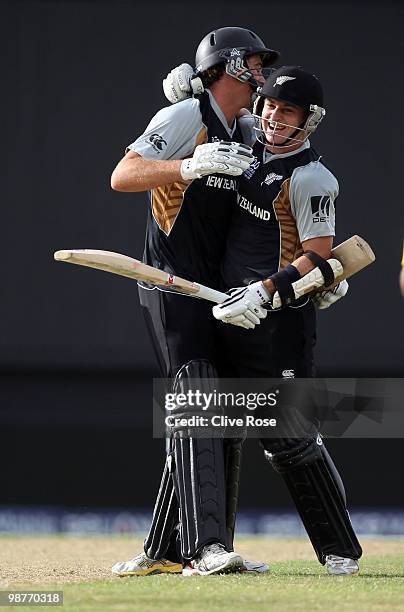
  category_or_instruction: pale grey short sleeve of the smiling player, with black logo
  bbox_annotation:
[289,161,339,242]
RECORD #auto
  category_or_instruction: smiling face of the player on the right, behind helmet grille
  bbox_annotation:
[261,98,307,153]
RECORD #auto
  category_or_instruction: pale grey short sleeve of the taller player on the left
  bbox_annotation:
[127,98,204,159]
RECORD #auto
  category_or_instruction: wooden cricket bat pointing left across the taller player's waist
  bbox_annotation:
[54,249,228,303]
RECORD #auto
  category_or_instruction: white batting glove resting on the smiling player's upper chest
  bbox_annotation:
[180,140,254,181]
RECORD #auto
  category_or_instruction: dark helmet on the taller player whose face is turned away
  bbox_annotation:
[195,27,279,87]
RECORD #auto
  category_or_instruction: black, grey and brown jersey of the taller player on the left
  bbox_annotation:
[129,92,242,288]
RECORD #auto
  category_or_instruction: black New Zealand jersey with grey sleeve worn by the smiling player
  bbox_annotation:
[222,141,338,289]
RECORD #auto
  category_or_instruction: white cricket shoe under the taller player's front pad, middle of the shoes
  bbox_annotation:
[182,542,244,576]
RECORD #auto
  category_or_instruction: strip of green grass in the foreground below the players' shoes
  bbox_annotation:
[12,554,404,612]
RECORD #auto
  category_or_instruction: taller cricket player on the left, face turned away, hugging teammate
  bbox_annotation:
[111,27,278,576]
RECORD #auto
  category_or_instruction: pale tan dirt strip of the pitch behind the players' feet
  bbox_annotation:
[0,536,404,589]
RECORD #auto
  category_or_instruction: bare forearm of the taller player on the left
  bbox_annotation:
[111,156,182,192]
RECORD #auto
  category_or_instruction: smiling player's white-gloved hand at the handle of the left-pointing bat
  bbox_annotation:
[212,281,271,329]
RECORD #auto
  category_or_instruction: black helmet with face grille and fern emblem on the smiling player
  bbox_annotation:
[253,66,325,148]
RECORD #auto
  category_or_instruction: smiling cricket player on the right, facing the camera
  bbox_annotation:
[213,66,362,575]
